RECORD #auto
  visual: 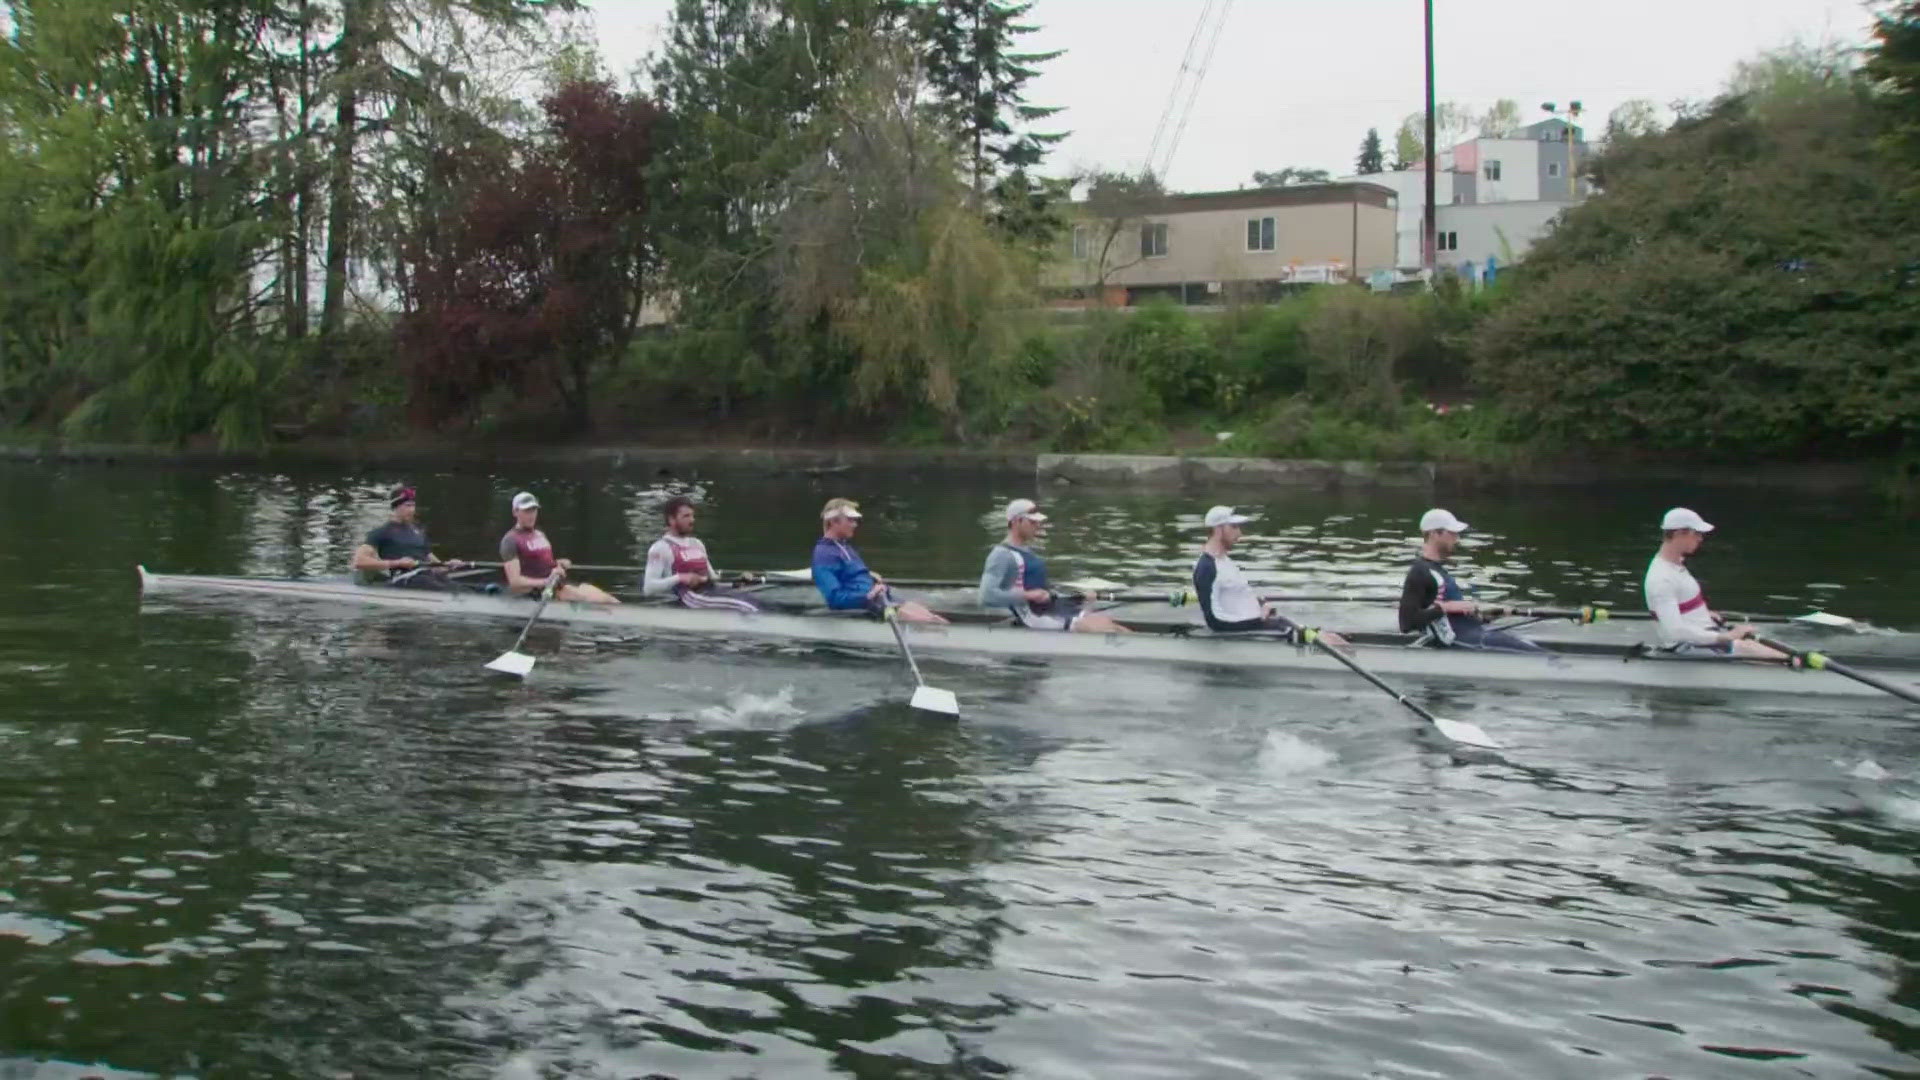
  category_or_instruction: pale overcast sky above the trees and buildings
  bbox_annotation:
[589,0,1872,190]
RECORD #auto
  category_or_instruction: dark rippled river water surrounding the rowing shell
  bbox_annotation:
[0,457,1920,1080]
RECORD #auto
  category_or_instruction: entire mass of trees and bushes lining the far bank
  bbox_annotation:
[0,0,1920,463]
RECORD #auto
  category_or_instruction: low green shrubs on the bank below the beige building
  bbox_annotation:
[622,284,1521,461]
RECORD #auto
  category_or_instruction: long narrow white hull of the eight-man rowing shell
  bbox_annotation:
[140,567,1920,698]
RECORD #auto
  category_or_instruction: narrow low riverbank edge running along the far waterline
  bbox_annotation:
[0,432,1899,494]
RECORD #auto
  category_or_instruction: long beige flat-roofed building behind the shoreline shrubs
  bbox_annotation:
[1044,183,1400,306]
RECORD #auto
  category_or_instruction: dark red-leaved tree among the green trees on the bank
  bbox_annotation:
[397,79,660,430]
